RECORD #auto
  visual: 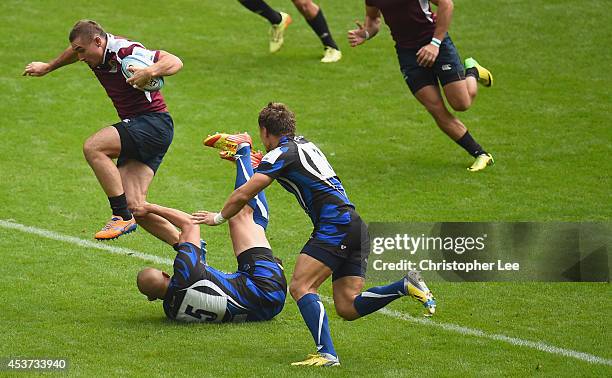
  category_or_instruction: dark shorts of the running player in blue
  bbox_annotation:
[302,209,370,281]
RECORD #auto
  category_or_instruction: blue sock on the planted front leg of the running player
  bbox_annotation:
[297,293,338,357]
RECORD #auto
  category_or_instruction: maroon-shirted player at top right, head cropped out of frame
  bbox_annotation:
[348,0,493,172]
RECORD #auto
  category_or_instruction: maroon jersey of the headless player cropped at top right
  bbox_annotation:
[366,0,436,49]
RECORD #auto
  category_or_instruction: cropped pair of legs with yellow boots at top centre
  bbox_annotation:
[239,0,342,63]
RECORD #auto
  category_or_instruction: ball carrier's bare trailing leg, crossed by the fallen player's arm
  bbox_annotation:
[119,159,179,246]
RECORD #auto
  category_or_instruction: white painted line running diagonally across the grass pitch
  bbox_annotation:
[0,219,612,366]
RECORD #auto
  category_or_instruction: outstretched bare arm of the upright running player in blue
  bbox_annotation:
[192,173,274,226]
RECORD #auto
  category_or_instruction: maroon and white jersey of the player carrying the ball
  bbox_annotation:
[92,33,168,119]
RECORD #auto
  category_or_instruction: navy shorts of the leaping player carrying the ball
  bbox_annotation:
[113,112,174,173]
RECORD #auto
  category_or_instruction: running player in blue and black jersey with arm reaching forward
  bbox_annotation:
[193,103,436,366]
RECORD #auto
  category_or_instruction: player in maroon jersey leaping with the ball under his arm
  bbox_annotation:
[23,20,183,239]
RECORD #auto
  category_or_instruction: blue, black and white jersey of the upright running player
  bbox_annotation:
[255,136,354,227]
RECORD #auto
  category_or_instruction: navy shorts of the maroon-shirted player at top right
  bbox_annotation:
[396,34,465,94]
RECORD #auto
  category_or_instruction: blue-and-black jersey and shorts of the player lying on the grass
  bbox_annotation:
[164,243,287,322]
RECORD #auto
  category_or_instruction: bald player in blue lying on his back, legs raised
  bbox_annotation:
[134,147,287,322]
